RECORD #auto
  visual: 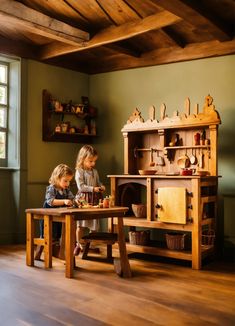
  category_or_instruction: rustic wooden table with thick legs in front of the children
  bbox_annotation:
[26,206,131,278]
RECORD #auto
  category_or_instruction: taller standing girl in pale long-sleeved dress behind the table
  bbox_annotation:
[74,145,105,256]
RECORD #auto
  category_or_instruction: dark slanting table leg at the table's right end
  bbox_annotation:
[118,217,131,278]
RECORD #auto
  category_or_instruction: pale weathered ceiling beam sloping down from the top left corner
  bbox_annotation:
[0,0,90,46]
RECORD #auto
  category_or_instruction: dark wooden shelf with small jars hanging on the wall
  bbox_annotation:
[42,89,97,143]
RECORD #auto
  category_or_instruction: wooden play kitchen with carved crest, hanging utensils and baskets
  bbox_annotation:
[109,95,221,269]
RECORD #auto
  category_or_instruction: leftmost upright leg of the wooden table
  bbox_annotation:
[26,213,35,266]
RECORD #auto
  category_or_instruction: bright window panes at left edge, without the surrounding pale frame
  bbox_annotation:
[0,61,9,166]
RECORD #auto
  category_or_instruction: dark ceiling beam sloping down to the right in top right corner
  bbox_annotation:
[150,0,232,42]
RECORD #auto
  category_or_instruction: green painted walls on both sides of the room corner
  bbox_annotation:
[0,56,235,256]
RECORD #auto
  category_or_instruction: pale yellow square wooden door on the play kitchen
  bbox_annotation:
[158,187,187,224]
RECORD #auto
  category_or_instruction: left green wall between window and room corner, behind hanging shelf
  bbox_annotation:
[27,61,89,207]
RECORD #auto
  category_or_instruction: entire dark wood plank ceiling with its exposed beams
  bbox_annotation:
[0,0,235,74]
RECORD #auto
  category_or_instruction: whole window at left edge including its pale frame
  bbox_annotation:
[0,53,20,169]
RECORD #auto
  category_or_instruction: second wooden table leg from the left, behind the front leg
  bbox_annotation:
[43,215,52,268]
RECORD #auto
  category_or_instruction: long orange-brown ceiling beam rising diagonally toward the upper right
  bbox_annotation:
[40,11,181,60]
